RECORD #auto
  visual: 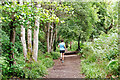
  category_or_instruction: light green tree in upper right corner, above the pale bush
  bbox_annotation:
[91,1,118,37]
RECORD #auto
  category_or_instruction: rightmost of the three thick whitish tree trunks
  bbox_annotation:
[32,16,39,61]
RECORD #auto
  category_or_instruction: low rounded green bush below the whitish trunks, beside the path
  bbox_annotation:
[23,62,47,78]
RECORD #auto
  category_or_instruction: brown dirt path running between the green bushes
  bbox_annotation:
[46,55,85,78]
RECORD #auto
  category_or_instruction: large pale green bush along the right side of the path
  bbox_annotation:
[81,33,119,78]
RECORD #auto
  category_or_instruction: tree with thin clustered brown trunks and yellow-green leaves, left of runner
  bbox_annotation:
[41,2,68,52]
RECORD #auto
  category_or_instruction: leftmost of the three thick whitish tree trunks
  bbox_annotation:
[20,0,27,61]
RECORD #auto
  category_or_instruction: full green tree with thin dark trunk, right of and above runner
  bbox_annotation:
[59,2,98,50]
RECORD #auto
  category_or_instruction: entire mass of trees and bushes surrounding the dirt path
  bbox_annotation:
[0,0,120,79]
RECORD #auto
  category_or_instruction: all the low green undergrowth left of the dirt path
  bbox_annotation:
[0,29,60,79]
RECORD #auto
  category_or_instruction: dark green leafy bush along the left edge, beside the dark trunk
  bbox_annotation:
[0,29,23,79]
